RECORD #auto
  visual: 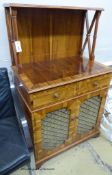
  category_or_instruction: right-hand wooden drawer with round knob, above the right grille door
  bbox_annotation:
[77,75,110,95]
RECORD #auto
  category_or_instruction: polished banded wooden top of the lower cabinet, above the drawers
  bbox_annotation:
[13,57,112,93]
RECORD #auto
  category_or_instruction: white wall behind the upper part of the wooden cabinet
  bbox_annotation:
[0,0,112,70]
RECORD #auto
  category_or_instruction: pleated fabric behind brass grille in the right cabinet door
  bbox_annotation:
[77,96,101,134]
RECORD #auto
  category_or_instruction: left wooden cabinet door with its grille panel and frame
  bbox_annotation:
[33,100,79,160]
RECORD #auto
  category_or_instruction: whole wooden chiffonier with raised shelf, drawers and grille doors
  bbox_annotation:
[5,4,112,168]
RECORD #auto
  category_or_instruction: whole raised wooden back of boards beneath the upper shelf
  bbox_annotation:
[17,8,85,64]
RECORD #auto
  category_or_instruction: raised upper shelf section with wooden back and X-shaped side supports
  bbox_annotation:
[5,4,103,67]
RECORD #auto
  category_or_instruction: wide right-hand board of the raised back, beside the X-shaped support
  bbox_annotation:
[52,10,85,59]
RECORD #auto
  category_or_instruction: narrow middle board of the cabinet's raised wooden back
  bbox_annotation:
[32,9,50,62]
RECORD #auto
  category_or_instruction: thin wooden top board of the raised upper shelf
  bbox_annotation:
[4,3,104,11]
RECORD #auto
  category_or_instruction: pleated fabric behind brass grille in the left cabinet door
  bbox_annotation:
[42,108,70,150]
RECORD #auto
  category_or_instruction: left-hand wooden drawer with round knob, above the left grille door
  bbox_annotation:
[30,83,77,109]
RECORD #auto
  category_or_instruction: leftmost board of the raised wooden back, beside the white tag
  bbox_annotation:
[17,8,32,64]
